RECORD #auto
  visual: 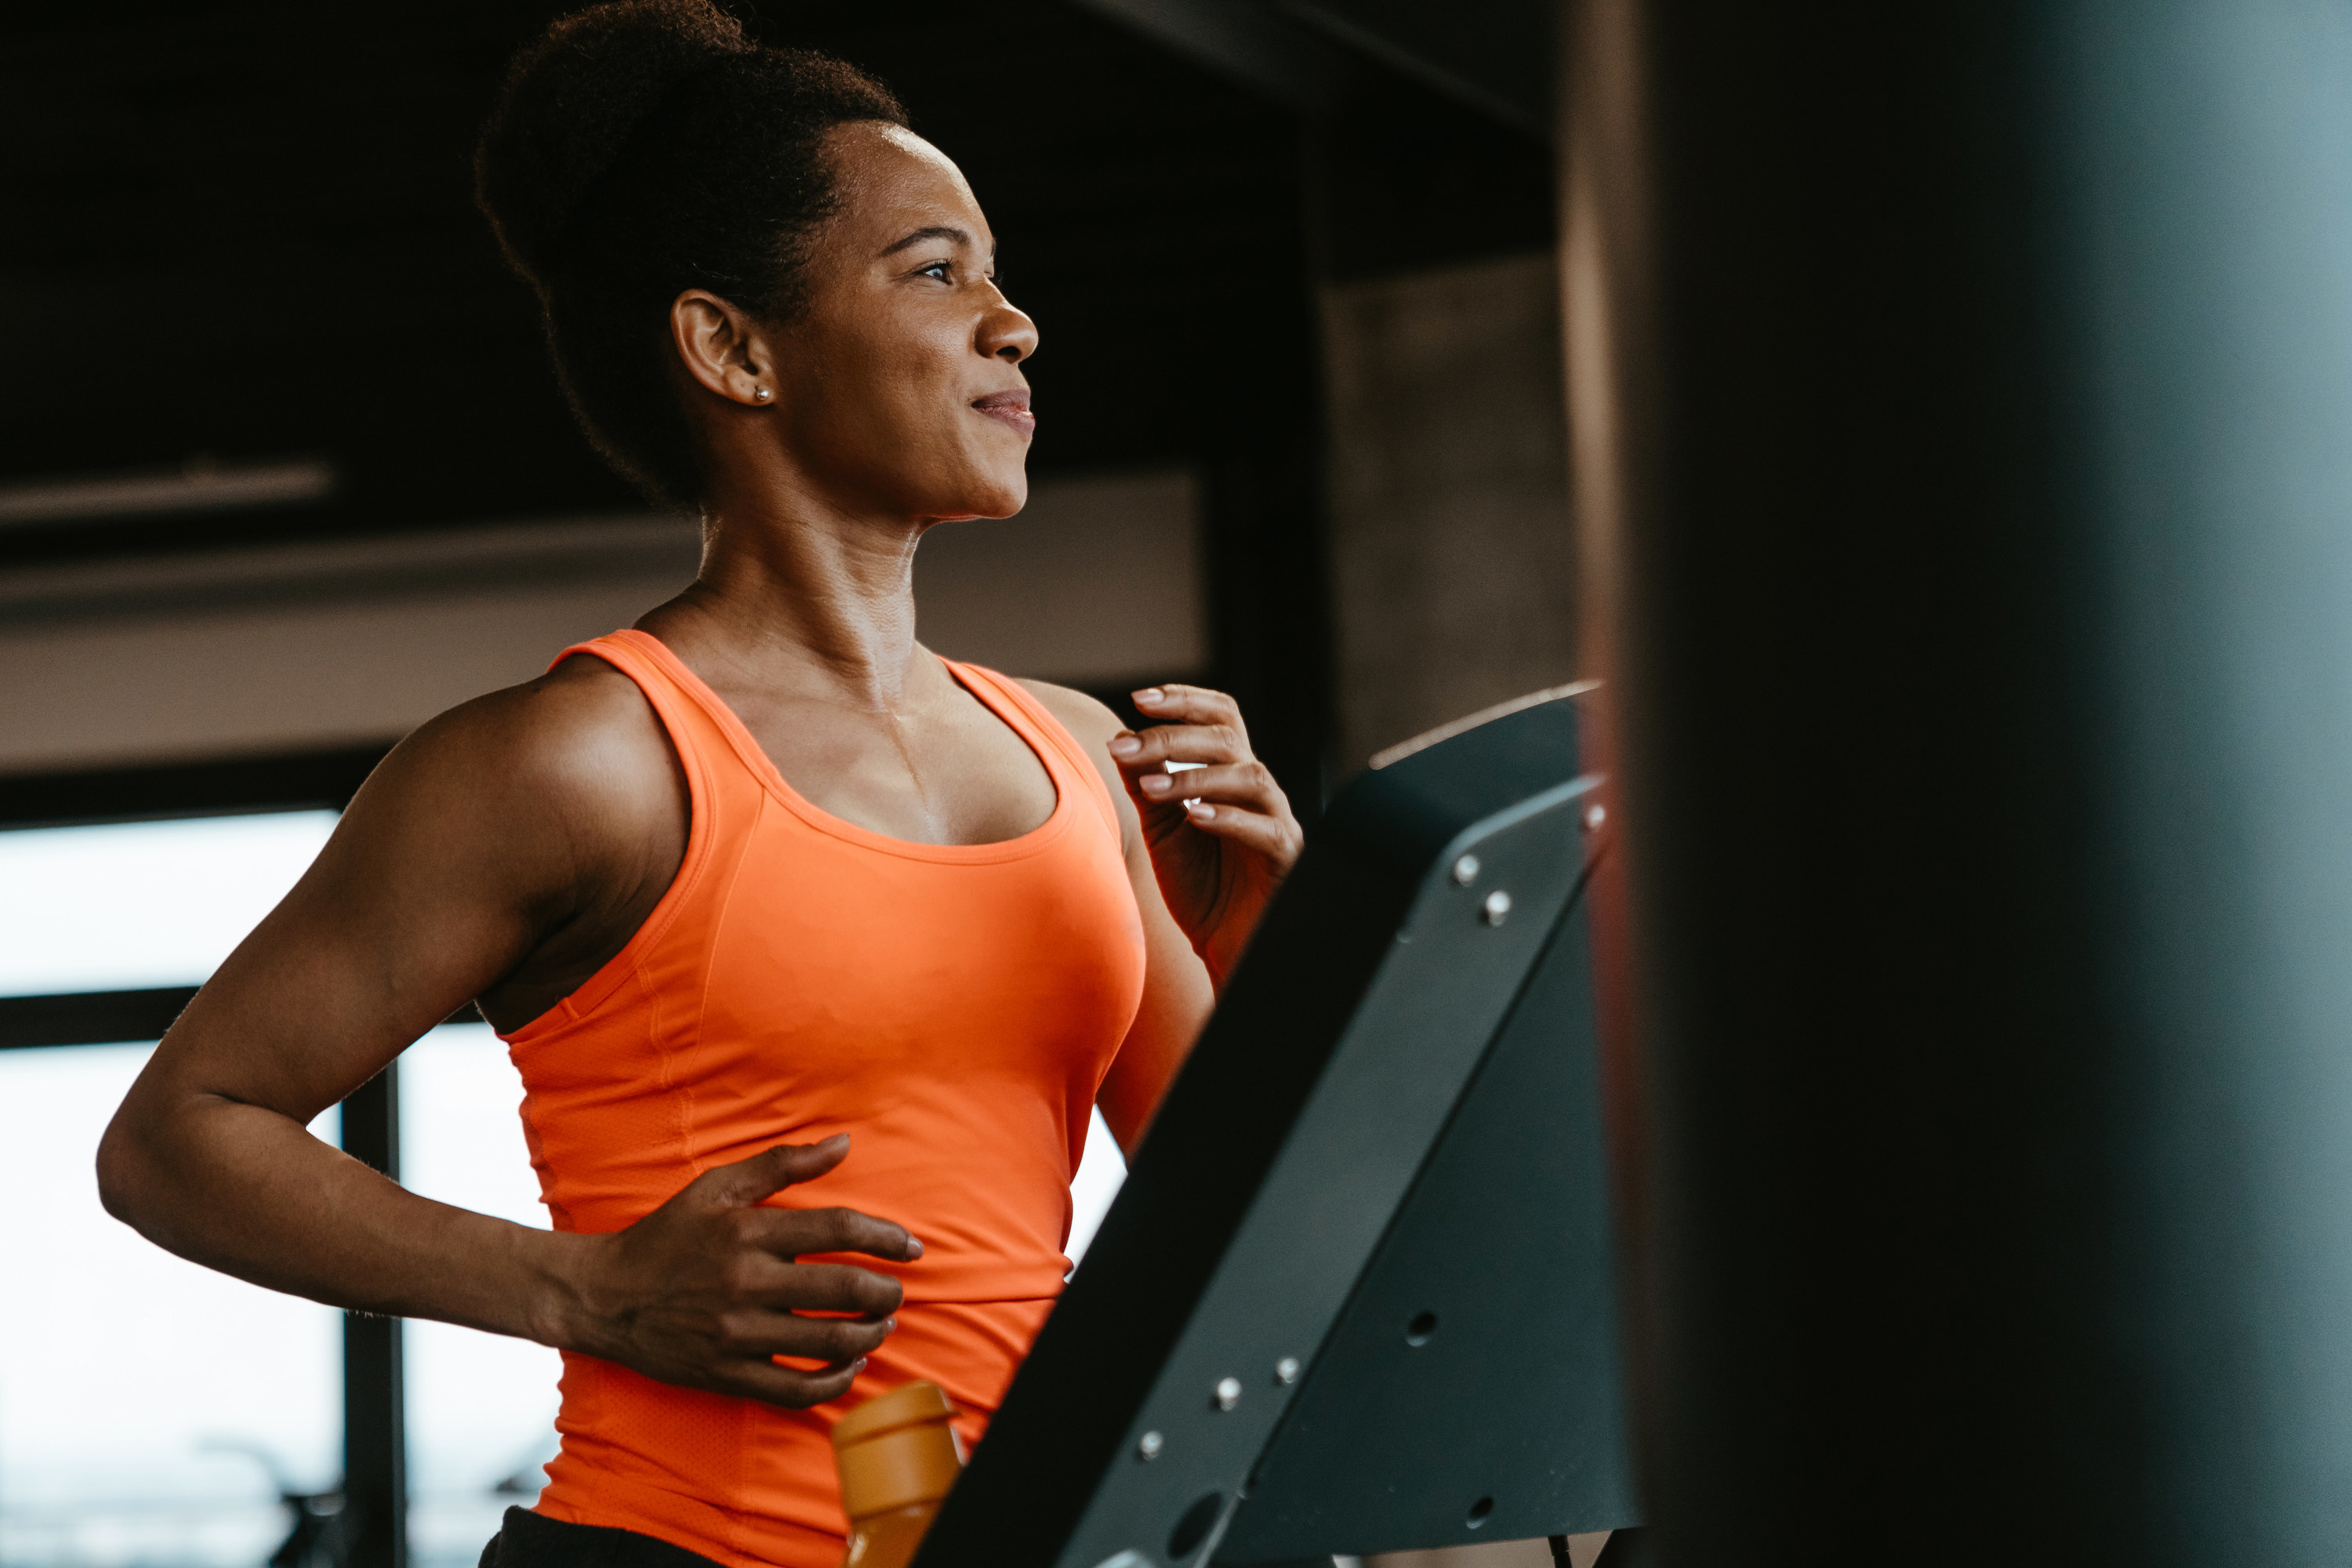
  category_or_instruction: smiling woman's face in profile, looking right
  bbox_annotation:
[771,122,1037,520]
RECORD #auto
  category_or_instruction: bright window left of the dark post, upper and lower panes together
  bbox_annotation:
[0,811,343,1566]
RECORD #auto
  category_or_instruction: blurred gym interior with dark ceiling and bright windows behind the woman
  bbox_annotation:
[0,0,1578,1568]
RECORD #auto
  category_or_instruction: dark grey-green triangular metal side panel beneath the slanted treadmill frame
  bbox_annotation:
[1218,898,1639,1563]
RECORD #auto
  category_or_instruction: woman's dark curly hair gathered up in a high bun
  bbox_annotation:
[473,0,906,506]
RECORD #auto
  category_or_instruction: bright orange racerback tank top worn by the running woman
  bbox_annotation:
[506,630,1143,1568]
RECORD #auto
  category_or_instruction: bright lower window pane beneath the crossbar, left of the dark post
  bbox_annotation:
[0,1046,343,1568]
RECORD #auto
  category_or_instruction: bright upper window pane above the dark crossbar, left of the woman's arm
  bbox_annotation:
[0,811,336,996]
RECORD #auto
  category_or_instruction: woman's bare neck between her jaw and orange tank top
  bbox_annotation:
[644,484,929,713]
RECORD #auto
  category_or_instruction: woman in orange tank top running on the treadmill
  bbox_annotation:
[99,0,1301,1568]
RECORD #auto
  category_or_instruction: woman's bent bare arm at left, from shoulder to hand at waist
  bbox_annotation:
[99,661,920,1406]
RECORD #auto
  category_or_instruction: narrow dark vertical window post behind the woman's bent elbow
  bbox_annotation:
[341,1065,409,1568]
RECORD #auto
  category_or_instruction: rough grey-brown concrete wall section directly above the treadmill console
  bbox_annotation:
[1324,252,1578,774]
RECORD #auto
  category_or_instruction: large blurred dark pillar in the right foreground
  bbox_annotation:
[1564,0,2352,1568]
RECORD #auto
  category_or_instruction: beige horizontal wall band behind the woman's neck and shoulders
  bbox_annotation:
[0,473,1209,774]
